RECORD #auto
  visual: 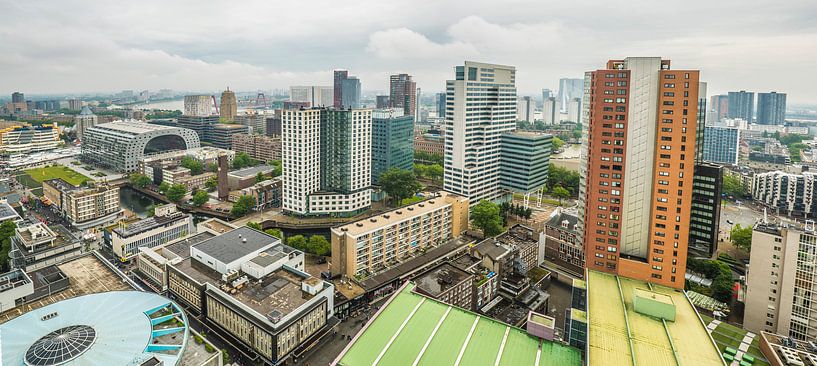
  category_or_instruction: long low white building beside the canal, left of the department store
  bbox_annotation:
[111,204,196,261]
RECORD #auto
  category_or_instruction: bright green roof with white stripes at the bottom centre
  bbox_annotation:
[335,283,582,366]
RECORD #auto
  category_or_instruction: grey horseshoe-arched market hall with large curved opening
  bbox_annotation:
[81,120,199,172]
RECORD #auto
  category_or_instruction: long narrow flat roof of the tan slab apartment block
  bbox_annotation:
[332,191,459,236]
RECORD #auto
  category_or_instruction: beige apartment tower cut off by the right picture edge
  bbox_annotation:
[743,221,817,341]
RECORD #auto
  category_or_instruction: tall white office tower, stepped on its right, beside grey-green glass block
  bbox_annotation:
[443,61,516,202]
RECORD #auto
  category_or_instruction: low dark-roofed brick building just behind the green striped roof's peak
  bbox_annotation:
[414,263,474,310]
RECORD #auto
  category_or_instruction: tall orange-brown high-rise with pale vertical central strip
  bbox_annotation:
[579,57,699,288]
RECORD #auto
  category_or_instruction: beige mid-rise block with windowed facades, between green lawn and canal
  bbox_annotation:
[43,178,122,230]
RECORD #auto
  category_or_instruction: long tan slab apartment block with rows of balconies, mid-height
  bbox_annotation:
[331,192,468,277]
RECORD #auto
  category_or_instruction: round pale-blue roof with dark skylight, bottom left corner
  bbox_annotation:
[0,291,188,366]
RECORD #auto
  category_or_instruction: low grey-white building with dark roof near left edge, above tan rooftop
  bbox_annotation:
[9,222,82,272]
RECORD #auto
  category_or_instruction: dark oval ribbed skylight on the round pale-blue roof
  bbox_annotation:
[25,325,96,366]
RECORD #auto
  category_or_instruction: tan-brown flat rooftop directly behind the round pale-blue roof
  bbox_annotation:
[0,255,133,324]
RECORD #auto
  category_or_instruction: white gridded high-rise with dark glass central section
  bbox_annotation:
[281,108,372,216]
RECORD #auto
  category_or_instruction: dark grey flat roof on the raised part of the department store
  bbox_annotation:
[196,226,281,263]
